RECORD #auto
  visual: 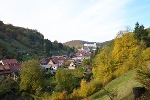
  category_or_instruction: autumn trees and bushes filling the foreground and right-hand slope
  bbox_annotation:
[0,22,150,100]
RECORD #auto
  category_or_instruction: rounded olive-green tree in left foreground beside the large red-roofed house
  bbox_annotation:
[19,60,43,93]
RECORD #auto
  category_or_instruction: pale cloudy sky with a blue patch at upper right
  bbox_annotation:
[0,0,150,43]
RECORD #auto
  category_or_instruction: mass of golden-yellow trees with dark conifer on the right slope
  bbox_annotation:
[92,23,150,84]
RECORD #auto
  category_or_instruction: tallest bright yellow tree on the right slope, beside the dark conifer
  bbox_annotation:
[112,33,142,76]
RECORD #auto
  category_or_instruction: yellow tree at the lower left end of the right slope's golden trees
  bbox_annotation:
[92,45,115,83]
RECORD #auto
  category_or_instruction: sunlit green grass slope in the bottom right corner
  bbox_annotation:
[88,70,142,100]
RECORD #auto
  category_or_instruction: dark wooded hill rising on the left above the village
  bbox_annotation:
[0,21,74,61]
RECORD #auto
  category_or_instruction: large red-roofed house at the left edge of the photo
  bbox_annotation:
[0,59,21,79]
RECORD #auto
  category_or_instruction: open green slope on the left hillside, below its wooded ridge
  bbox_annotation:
[0,32,45,61]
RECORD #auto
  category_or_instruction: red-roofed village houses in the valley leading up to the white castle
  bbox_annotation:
[0,42,97,79]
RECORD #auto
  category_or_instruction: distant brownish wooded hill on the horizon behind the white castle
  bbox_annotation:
[64,40,111,49]
